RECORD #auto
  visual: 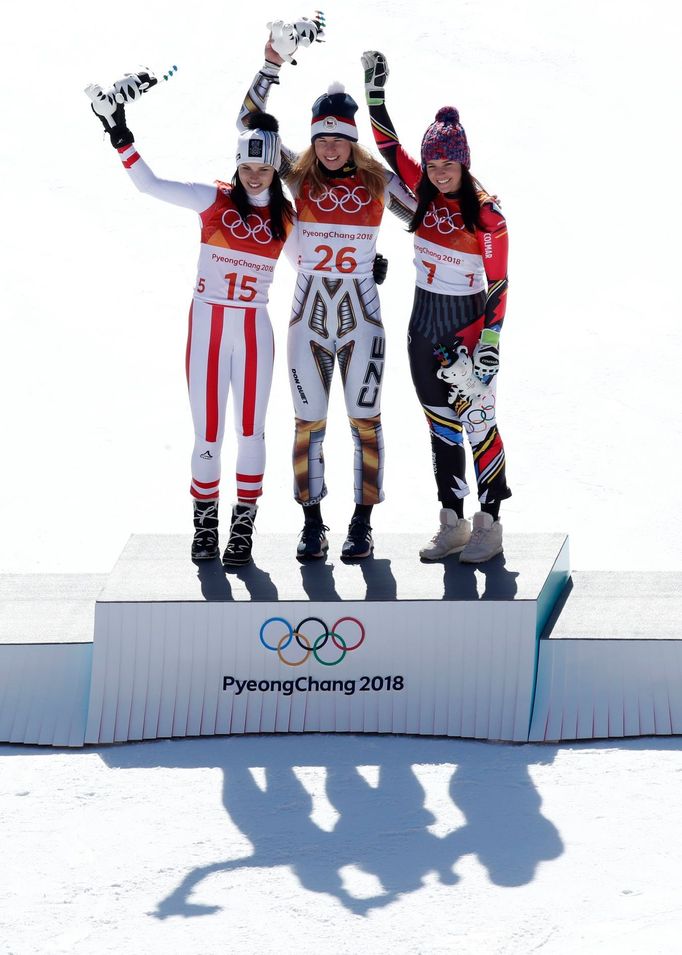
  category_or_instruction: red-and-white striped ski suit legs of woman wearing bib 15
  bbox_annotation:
[186,299,274,503]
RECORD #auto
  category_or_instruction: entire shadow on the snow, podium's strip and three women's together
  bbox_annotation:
[100,735,563,918]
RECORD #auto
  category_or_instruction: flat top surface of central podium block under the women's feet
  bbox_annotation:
[98,534,567,603]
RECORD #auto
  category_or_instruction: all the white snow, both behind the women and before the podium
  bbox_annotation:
[0,0,682,955]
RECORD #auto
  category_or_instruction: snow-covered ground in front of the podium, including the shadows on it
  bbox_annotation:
[0,736,682,955]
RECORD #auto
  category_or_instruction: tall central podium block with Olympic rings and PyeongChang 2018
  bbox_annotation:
[85,534,569,743]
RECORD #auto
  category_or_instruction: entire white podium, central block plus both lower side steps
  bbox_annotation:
[5,534,682,746]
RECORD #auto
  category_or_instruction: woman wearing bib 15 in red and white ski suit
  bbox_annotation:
[93,87,294,564]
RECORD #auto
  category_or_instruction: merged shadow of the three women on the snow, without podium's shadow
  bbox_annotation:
[155,740,563,919]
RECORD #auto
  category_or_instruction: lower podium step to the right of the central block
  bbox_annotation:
[529,572,682,741]
